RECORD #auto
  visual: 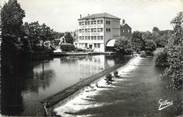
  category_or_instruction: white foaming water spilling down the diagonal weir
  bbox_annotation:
[54,55,142,117]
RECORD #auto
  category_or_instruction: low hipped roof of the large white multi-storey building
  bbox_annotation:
[79,13,120,20]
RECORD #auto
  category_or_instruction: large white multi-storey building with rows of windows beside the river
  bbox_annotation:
[74,13,120,52]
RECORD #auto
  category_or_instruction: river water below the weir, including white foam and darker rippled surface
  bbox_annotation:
[54,56,183,117]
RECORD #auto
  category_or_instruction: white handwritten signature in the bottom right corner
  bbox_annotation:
[158,99,173,111]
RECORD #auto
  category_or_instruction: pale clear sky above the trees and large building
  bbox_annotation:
[1,0,183,32]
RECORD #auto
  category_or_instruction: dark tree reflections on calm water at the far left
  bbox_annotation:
[1,59,54,115]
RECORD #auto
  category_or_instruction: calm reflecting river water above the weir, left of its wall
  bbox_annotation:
[1,55,130,116]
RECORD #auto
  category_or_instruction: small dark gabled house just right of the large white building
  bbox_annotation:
[120,19,132,37]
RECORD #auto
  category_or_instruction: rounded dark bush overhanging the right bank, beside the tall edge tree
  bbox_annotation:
[155,51,169,67]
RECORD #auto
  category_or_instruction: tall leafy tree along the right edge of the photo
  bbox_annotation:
[163,12,183,89]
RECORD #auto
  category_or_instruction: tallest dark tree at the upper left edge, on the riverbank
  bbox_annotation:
[1,0,25,68]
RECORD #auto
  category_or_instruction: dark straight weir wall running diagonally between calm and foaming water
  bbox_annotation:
[41,56,131,115]
